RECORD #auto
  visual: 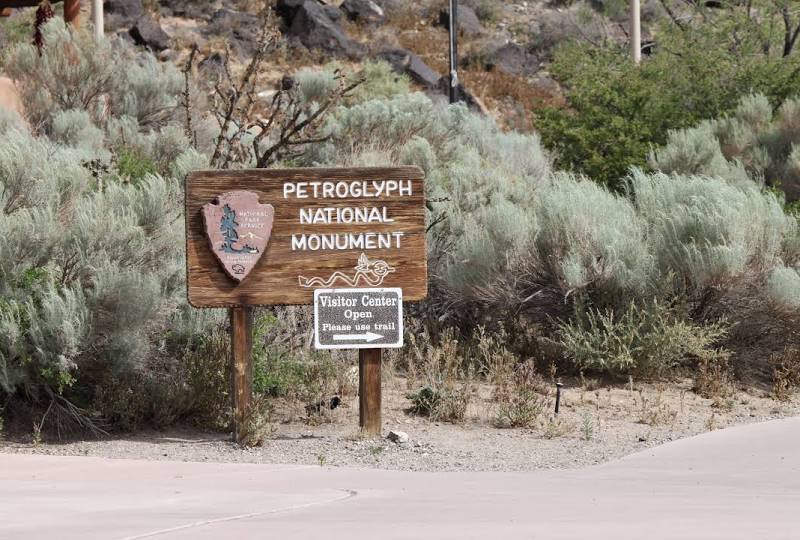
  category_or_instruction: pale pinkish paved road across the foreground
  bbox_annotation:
[0,418,800,540]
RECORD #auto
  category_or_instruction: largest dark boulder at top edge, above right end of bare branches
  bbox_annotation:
[286,0,366,59]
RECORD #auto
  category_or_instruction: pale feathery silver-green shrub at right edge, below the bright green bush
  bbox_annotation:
[629,170,797,290]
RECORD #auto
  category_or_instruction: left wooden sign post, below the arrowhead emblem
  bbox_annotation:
[230,306,253,442]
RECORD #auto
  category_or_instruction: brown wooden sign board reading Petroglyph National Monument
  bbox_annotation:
[186,167,427,307]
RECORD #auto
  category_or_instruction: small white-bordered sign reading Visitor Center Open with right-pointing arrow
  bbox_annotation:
[314,288,403,349]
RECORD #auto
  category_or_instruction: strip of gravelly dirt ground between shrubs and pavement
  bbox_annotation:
[0,378,800,471]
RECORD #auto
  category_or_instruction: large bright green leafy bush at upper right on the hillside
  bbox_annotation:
[536,13,800,188]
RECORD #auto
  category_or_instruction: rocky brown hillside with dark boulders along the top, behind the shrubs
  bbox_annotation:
[0,0,659,130]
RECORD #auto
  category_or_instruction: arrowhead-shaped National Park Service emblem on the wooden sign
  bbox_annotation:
[203,191,275,282]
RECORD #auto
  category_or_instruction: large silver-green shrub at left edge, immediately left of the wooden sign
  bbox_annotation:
[0,122,182,393]
